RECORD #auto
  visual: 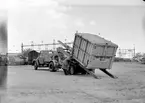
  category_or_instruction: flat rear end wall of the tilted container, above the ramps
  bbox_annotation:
[88,45,116,69]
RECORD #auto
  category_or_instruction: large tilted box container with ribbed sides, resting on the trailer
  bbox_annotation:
[72,33,118,69]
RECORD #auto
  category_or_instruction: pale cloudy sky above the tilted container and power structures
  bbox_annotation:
[3,0,145,52]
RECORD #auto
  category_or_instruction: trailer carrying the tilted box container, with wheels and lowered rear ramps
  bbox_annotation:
[58,33,118,78]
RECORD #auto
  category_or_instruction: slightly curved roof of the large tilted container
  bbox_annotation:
[76,33,118,47]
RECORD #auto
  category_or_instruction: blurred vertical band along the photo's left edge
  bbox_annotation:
[0,4,8,103]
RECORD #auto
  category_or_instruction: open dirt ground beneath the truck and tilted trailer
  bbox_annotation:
[3,63,145,103]
